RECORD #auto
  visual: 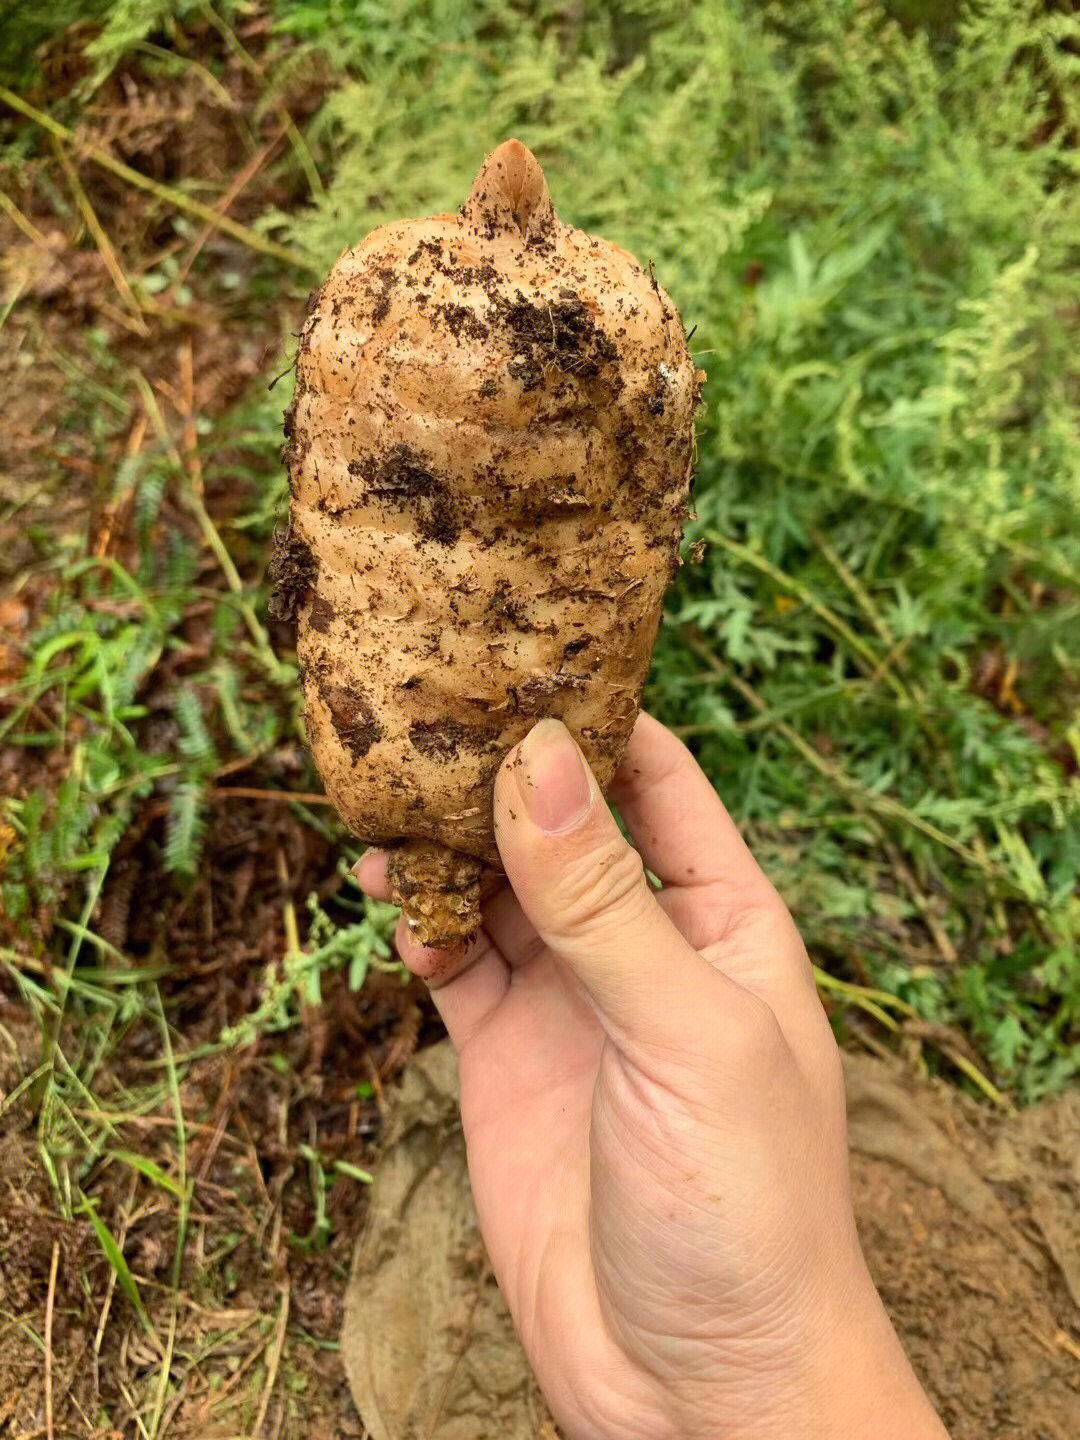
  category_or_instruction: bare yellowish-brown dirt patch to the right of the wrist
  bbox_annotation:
[847,1057,1080,1440]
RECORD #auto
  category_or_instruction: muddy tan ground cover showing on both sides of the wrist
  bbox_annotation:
[341,1044,1080,1440]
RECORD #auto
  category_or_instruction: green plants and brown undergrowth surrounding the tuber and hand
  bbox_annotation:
[0,0,1080,1436]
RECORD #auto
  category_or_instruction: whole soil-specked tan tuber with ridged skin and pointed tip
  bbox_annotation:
[275,140,704,946]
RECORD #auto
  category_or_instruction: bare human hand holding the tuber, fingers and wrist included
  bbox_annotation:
[357,714,945,1440]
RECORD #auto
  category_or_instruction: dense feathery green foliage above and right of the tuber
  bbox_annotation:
[262,0,1080,1096]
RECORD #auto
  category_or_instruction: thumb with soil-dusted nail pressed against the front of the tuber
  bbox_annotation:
[495,720,749,1051]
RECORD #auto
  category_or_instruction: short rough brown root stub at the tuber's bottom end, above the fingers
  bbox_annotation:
[386,840,487,950]
